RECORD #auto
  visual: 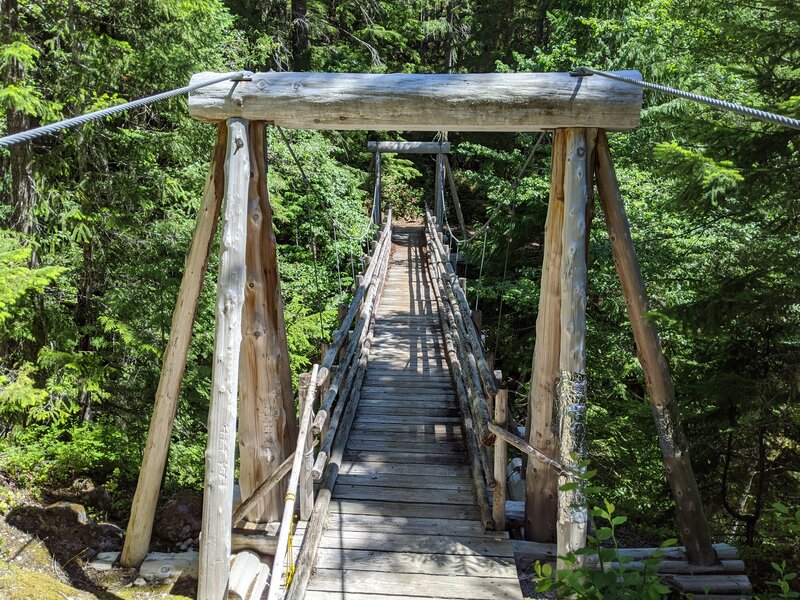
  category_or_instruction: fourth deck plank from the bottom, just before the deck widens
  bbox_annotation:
[326,513,488,537]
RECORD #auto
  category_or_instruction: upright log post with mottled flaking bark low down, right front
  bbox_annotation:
[556,129,592,568]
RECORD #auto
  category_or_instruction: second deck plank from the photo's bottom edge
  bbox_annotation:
[317,548,517,579]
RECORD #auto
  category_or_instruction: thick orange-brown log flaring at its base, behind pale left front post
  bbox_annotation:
[239,122,297,523]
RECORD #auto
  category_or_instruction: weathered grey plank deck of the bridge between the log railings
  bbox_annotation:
[306,227,522,600]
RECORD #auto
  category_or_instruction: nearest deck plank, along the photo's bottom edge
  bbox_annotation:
[313,569,522,600]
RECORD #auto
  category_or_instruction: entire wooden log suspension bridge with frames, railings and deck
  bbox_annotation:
[0,69,788,600]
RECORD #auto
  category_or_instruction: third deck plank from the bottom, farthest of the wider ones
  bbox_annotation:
[320,531,514,559]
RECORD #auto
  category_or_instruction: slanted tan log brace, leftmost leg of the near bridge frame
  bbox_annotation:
[120,123,228,567]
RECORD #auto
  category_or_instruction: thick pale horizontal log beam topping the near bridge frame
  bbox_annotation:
[189,71,642,131]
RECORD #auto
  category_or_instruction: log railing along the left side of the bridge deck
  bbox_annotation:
[272,206,392,600]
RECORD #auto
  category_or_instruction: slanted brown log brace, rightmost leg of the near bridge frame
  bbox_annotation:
[597,133,716,565]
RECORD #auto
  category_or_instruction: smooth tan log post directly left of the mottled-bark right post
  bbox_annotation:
[525,129,566,542]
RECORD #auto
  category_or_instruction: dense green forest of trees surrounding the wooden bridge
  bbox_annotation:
[0,0,800,598]
